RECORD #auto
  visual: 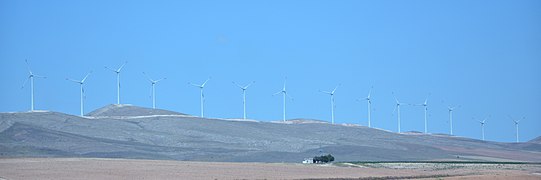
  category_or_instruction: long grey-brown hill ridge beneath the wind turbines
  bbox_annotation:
[0,105,541,162]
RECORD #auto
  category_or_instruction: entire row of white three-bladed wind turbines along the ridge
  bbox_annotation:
[22,60,524,142]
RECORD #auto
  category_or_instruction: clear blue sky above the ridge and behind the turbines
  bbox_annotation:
[0,0,541,142]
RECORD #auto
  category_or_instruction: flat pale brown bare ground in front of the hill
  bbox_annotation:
[0,158,541,180]
